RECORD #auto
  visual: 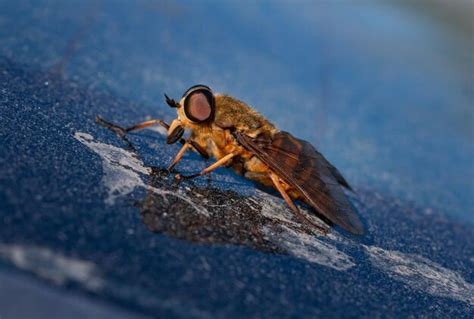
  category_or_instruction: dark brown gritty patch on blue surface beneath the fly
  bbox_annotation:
[140,168,313,253]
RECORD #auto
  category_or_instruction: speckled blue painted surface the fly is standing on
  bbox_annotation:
[0,1,474,318]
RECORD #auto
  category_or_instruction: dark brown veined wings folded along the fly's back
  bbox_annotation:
[234,131,363,234]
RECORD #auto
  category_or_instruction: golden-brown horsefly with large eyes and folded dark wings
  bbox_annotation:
[99,85,363,234]
